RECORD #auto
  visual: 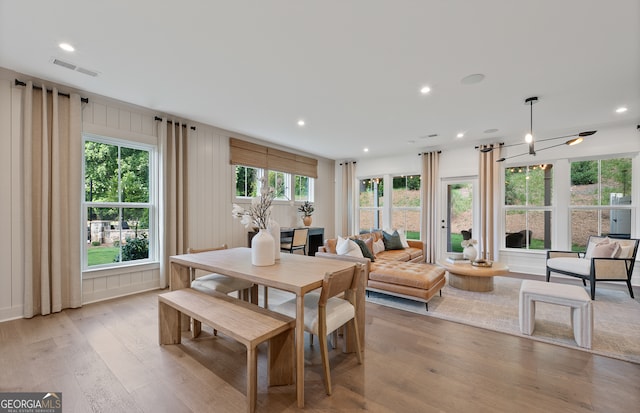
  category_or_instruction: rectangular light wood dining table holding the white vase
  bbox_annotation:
[169,248,365,408]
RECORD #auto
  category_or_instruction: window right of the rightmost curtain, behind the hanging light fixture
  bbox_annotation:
[504,164,553,249]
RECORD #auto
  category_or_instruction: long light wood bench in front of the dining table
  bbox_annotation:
[158,288,295,413]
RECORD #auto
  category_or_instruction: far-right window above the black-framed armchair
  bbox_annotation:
[570,158,632,250]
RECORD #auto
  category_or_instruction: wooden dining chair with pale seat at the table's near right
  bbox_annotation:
[273,264,362,395]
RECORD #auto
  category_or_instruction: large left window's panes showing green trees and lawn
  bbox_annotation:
[83,137,156,268]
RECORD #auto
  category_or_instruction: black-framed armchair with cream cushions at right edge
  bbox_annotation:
[547,236,639,300]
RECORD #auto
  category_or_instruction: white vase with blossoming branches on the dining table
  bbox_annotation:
[231,177,280,267]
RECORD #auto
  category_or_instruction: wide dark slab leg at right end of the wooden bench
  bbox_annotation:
[267,329,295,386]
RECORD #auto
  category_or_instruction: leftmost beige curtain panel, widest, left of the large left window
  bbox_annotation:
[22,82,86,318]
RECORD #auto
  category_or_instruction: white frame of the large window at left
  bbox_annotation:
[80,132,159,273]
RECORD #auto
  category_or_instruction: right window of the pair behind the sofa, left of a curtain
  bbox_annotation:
[391,175,420,240]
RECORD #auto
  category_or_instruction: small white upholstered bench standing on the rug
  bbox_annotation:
[519,280,593,348]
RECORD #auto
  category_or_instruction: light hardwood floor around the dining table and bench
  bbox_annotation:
[0,284,640,413]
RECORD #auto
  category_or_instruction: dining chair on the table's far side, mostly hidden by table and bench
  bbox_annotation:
[187,244,258,337]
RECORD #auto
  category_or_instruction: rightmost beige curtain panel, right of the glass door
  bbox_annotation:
[478,144,501,261]
